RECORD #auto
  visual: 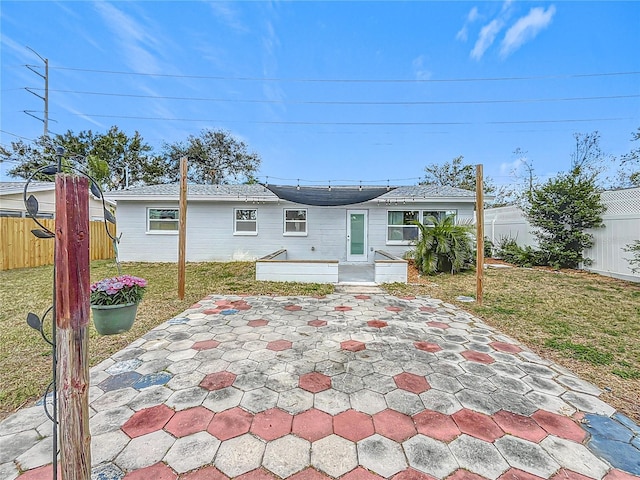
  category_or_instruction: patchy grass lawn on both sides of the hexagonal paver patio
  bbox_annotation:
[0,261,640,421]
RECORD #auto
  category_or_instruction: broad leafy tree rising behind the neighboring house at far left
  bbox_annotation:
[0,126,167,190]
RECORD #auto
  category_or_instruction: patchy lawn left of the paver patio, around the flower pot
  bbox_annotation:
[0,261,333,418]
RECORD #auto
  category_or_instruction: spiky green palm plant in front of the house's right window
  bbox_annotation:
[411,215,473,275]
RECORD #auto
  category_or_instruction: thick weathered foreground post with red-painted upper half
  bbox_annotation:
[54,174,91,480]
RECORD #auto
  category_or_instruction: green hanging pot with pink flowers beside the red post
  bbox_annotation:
[90,275,147,335]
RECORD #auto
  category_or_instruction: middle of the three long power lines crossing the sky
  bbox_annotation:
[35,88,640,105]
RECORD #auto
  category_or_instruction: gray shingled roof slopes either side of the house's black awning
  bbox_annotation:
[105,184,475,200]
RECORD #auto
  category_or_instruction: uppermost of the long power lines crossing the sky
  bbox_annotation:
[40,65,640,83]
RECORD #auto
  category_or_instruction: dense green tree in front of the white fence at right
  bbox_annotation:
[525,133,605,268]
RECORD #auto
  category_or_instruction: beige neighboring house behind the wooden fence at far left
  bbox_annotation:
[0,182,115,221]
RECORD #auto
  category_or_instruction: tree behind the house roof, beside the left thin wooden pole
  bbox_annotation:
[163,129,260,185]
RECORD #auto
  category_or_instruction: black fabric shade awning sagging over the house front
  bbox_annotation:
[265,185,395,207]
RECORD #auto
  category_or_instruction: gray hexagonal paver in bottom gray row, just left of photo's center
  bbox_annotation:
[262,435,311,478]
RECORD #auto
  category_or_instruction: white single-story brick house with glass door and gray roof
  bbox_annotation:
[106,185,475,264]
